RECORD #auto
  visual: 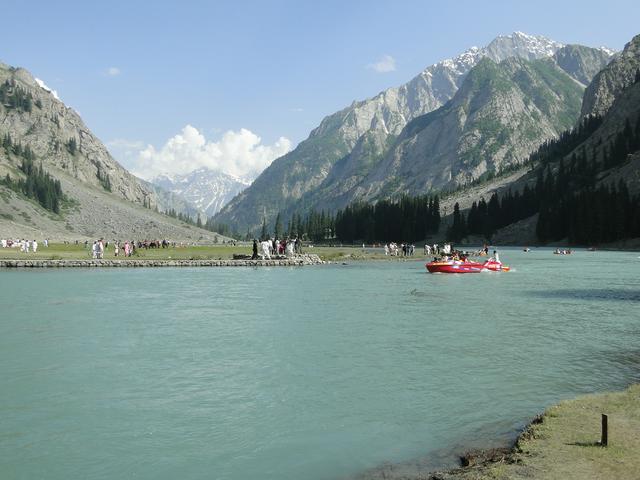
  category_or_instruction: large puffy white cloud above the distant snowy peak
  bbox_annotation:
[124,125,291,179]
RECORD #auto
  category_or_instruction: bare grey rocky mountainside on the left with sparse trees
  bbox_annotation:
[0,60,228,240]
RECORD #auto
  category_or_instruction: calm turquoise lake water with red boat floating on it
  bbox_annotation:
[0,249,640,480]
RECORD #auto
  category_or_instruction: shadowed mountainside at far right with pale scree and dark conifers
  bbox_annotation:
[456,36,640,248]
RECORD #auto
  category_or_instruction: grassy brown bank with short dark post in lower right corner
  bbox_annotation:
[430,385,640,480]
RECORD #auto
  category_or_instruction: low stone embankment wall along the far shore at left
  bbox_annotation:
[0,254,325,268]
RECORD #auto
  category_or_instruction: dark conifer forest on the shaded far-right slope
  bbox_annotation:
[448,109,640,244]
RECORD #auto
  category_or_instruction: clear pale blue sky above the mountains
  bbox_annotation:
[0,0,640,178]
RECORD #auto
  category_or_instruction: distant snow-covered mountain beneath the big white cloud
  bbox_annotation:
[151,168,251,216]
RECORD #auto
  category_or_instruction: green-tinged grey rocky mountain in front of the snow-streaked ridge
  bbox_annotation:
[318,46,608,209]
